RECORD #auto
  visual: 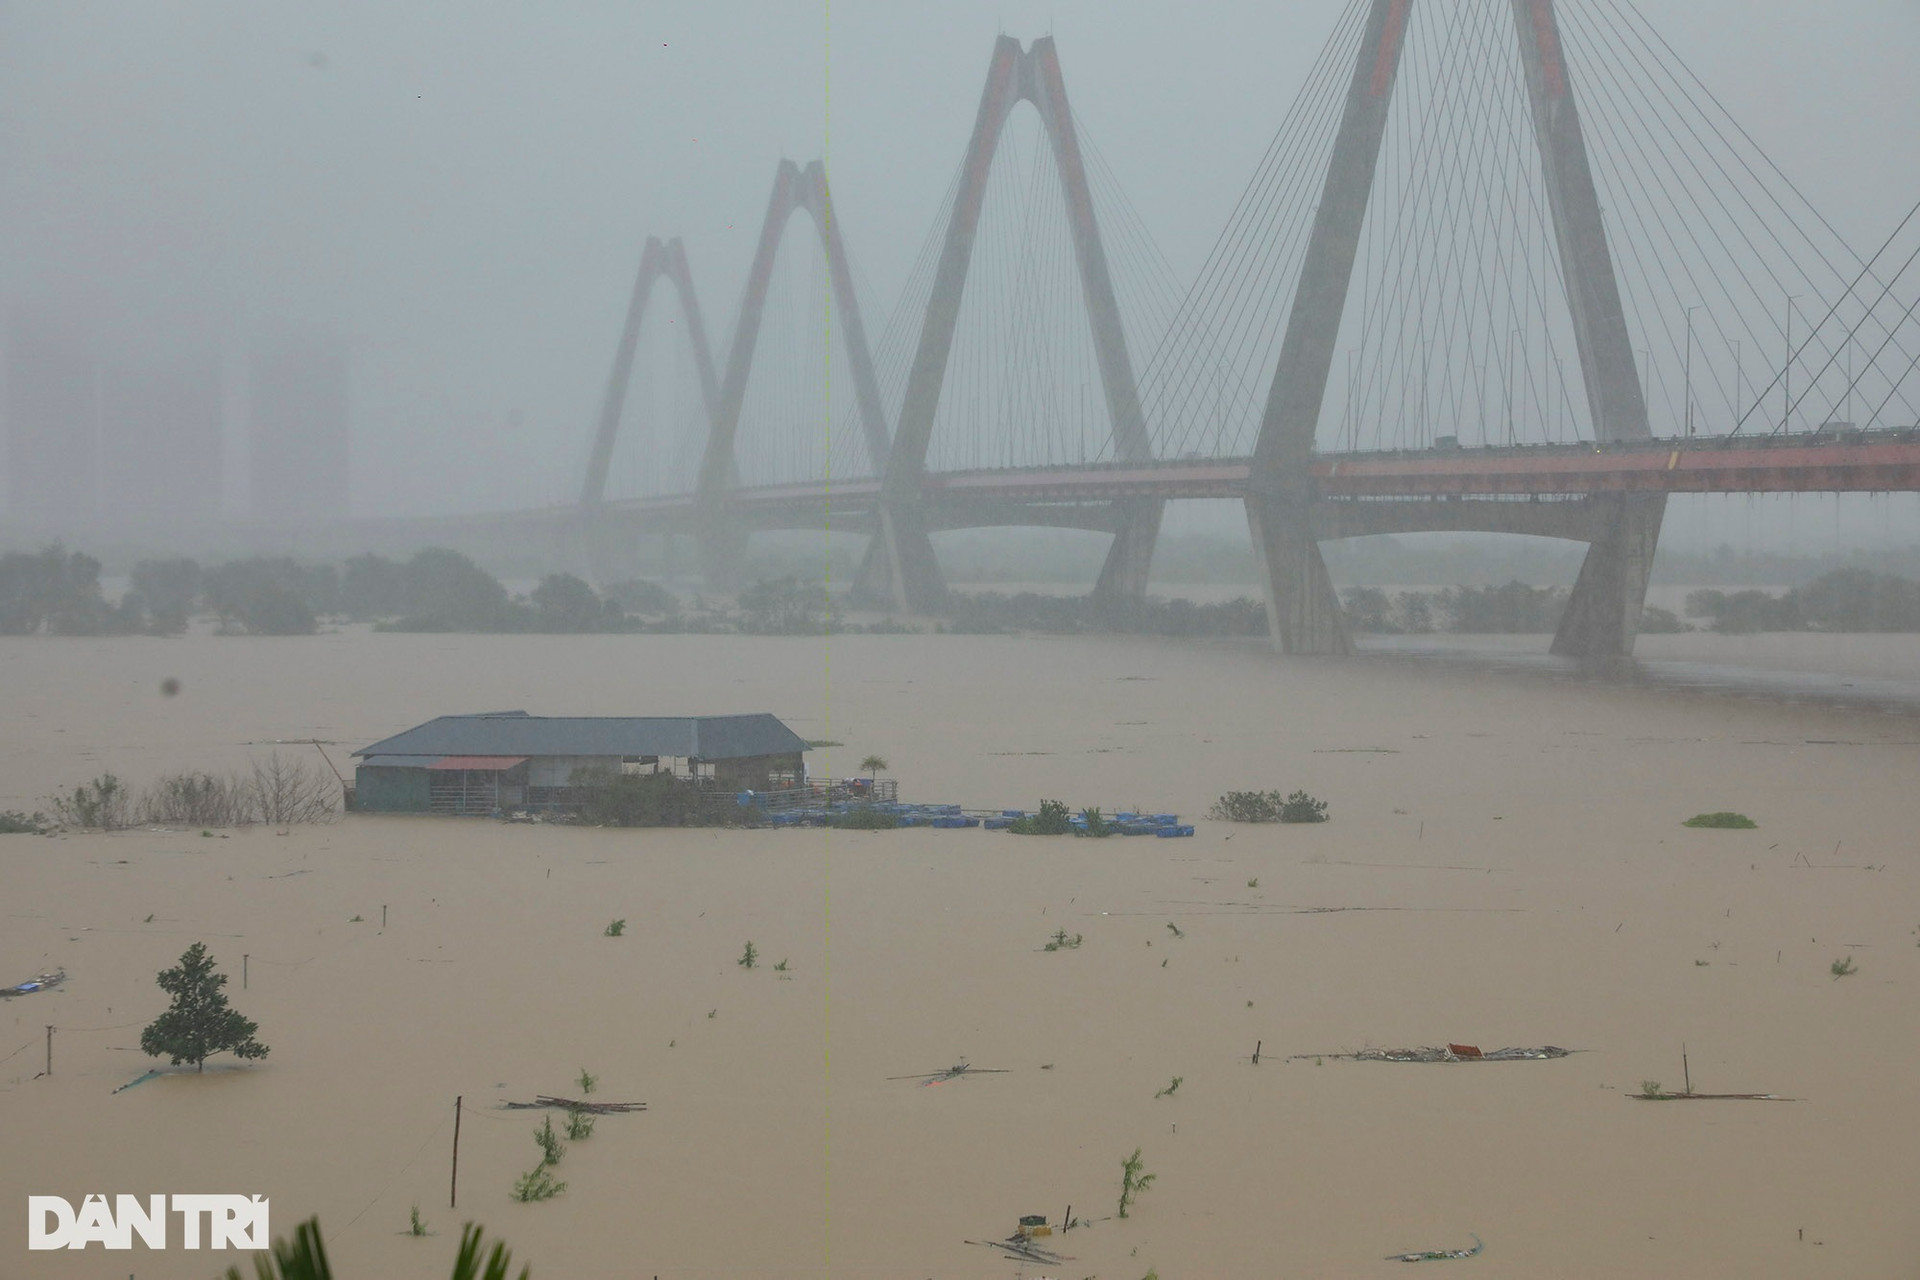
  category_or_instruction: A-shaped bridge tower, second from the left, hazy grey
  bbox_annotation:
[695,159,891,585]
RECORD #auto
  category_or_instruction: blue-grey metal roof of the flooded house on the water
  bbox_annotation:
[353,712,806,766]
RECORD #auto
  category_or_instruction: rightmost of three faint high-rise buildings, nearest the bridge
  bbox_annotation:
[248,328,348,524]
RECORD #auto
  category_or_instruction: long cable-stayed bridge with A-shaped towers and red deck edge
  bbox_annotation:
[503,0,1920,656]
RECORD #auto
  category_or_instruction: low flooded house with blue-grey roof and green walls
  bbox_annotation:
[353,712,806,816]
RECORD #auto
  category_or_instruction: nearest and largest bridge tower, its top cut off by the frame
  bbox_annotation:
[1246,0,1665,658]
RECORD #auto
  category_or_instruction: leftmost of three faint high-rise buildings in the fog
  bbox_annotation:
[6,309,98,530]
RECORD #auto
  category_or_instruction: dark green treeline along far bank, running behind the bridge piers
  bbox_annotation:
[0,545,1920,637]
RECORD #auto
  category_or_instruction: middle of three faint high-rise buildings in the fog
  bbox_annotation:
[100,353,225,524]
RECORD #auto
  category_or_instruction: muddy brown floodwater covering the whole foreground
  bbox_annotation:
[0,629,1920,1280]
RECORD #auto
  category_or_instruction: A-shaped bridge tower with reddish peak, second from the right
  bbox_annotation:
[858,36,1164,612]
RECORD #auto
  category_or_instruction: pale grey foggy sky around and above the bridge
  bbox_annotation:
[0,0,1920,541]
